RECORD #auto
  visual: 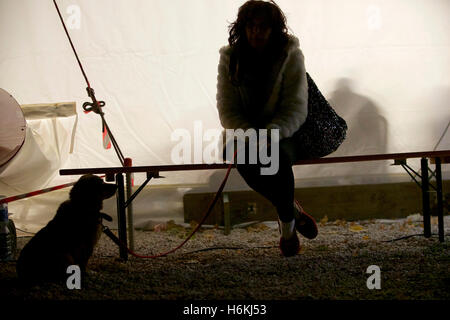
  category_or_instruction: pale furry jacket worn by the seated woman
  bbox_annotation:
[216,35,308,151]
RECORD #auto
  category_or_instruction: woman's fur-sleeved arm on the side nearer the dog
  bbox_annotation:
[216,46,251,130]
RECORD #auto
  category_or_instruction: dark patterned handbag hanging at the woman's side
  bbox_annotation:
[293,73,347,158]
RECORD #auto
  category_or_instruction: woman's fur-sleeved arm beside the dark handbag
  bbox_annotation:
[266,47,308,139]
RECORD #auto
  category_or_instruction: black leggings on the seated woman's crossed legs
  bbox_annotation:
[230,138,307,222]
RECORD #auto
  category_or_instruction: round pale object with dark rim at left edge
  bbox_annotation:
[0,88,27,167]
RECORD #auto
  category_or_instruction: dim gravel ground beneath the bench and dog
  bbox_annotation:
[0,215,450,301]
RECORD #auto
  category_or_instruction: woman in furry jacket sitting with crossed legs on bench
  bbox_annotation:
[217,0,318,257]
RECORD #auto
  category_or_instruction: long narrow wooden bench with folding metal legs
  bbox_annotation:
[59,150,450,260]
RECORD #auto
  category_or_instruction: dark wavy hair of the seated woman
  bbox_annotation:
[228,0,289,85]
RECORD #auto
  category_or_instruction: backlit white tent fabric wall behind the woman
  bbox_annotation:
[0,0,450,230]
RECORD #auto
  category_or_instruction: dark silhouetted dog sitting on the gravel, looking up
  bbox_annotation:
[16,175,117,284]
